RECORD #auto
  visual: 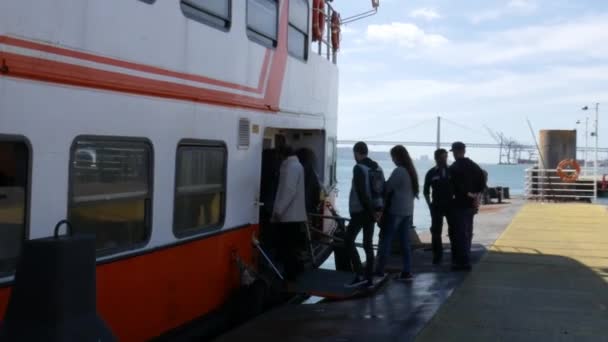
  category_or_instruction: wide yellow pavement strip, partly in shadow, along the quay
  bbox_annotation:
[416,204,608,342]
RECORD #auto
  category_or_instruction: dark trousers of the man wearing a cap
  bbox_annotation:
[452,208,475,265]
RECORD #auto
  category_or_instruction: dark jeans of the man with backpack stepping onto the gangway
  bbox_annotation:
[344,212,376,279]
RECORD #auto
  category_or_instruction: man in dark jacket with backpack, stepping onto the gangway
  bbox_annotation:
[345,141,382,287]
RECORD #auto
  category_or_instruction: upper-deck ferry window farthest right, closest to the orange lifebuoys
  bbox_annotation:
[287,0,308,60]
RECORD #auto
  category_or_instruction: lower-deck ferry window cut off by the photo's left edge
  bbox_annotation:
[0,141,30,276]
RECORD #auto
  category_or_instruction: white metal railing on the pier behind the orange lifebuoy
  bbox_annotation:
[525,168,598,202]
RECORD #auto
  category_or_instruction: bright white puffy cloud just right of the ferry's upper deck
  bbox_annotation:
[366,22,448,48]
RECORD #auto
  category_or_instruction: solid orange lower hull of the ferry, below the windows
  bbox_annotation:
[0,225,258,341]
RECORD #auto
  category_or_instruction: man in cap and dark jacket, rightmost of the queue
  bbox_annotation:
[449,142,486,270]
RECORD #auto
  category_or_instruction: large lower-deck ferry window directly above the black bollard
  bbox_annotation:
[68,137,152,255]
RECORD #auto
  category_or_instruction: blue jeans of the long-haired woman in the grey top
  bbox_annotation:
[376,214,412,273]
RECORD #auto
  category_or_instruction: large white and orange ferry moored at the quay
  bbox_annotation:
[0,0,360,341]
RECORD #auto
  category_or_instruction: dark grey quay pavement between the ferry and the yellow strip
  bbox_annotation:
[217,203,521,342]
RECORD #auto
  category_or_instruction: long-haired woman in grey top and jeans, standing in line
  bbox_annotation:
[376,145,419,280]
